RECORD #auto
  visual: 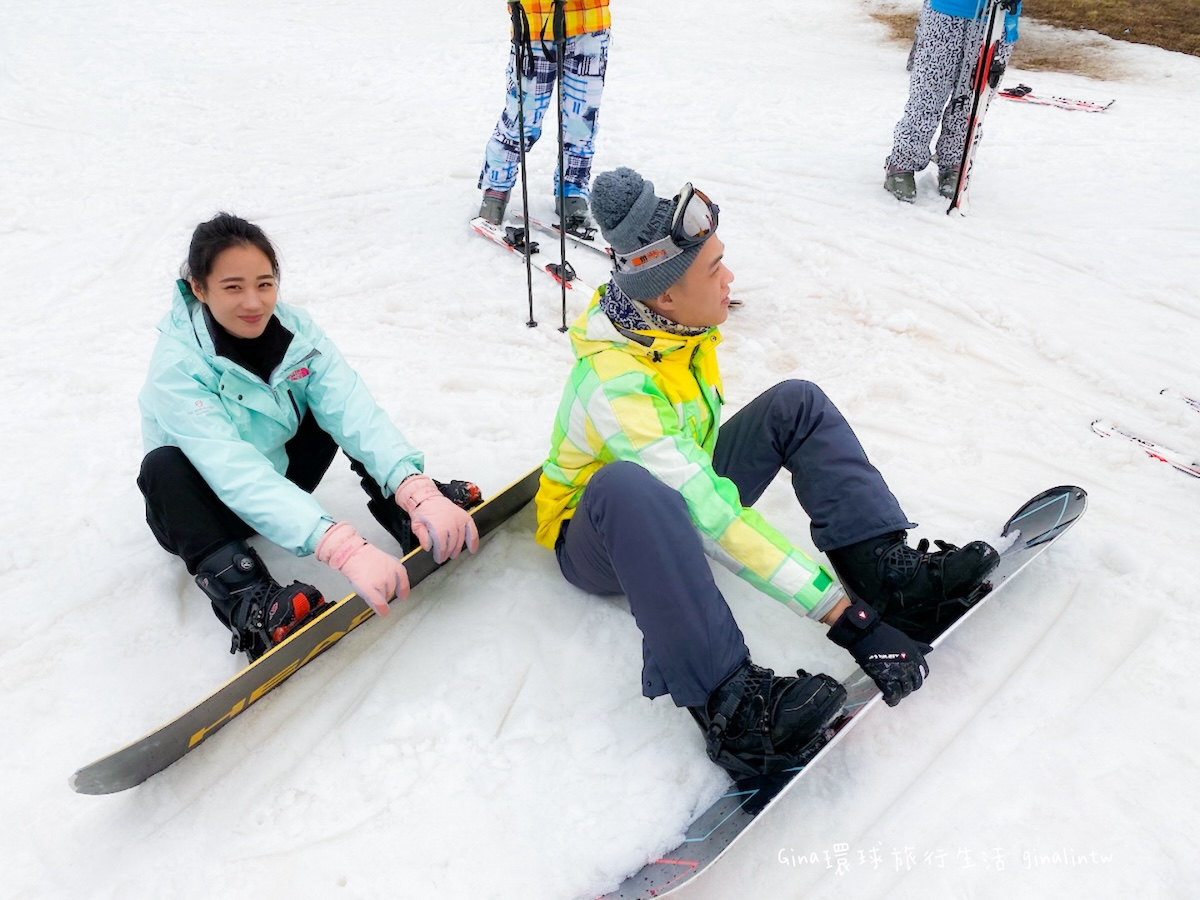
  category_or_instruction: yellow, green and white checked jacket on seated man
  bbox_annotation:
[536,288,842,618]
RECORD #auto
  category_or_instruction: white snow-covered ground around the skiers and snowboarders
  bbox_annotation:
[0,0,1200,900]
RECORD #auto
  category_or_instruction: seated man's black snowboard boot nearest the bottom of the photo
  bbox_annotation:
[689,660,846,778]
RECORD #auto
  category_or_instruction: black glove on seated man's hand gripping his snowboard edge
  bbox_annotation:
[828,600,934,707]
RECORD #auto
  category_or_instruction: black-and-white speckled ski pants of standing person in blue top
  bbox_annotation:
[884,0,1013,172]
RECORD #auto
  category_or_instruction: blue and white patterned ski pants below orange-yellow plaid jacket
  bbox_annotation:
[479,31,608,197]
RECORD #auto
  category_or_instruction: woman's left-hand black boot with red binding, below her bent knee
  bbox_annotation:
[196,541,328,662]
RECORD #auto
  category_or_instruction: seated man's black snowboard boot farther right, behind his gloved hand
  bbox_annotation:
[827,532,1000,643]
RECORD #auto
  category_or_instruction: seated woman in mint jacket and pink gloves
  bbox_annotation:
[138,212,479,660]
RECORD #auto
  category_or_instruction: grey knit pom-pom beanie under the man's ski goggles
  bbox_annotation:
[592,167,703,301]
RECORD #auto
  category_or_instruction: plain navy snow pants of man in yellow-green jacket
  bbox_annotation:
[556,380,916,707]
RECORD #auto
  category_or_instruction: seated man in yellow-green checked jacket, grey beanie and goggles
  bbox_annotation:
[536,168,998,775]
